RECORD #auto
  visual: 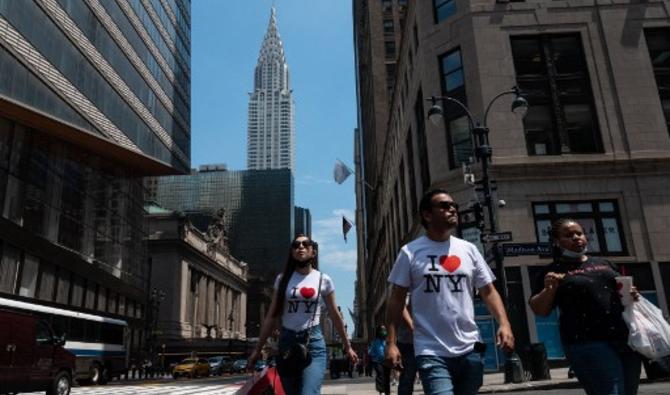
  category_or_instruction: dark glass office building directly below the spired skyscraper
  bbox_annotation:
[155,166,295,337]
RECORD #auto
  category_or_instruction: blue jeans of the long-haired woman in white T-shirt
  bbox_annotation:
[279,325,326,395]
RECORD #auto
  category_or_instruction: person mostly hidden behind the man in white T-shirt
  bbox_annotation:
[396,302,416,395]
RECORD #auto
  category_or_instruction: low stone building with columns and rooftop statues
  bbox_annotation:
[148,206,248,355]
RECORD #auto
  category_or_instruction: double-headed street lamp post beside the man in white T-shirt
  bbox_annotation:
[426,86,528,382]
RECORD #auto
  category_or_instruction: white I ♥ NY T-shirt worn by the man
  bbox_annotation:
[388,236,495,357]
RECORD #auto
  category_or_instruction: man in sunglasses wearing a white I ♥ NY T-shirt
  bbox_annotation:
[386,189,514,395]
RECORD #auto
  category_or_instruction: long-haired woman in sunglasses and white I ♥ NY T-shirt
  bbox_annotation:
[247,235,358,395]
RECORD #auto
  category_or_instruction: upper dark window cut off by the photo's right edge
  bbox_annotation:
[645,28,670,133]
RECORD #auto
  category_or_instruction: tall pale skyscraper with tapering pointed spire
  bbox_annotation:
[247,7,295,170]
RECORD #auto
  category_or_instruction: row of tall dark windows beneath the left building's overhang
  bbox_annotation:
[0,118,146,286]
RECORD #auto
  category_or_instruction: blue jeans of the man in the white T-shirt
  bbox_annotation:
[416,352,484,395]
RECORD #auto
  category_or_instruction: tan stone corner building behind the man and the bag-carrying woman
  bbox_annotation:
[354,0,670,369]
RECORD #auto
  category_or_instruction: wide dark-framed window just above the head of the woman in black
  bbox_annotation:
[533,200,626,255]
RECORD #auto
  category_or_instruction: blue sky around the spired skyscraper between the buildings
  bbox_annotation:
[191,0,356,333]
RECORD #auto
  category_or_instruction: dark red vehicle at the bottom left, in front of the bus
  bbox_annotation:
[0,310,75,395]
